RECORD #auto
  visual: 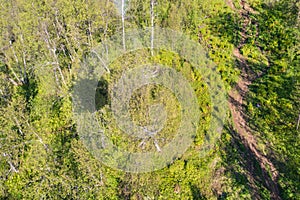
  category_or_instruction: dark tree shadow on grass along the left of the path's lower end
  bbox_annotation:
[221,125,271,199]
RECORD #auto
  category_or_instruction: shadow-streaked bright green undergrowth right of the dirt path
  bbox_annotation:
[243,1,300,199]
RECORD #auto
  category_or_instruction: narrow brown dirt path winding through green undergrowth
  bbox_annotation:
[227,0,281,199]
